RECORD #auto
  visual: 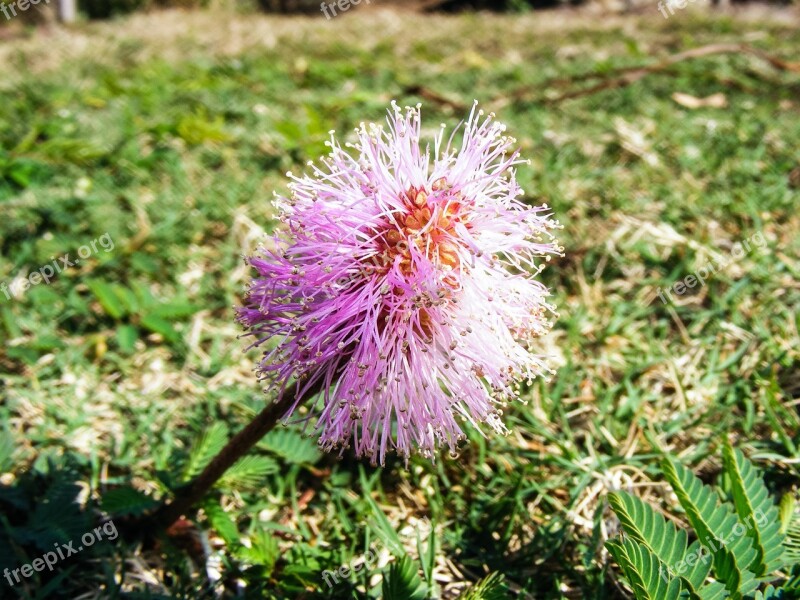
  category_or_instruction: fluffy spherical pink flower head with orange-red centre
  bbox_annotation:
[238,103,561,464]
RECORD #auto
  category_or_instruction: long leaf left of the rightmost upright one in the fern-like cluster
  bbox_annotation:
[662,458,758,598]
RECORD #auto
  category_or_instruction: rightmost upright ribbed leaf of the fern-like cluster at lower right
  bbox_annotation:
[722,443,783,577]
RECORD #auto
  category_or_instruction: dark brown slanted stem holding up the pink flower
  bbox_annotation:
[145,385,319,530]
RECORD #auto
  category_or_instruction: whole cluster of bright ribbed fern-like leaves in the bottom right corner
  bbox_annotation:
[606,444,790,600]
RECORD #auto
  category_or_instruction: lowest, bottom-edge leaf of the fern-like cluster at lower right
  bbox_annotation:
[606,538,681,600]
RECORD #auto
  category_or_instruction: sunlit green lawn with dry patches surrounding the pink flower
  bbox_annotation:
[0,8,800,599]
